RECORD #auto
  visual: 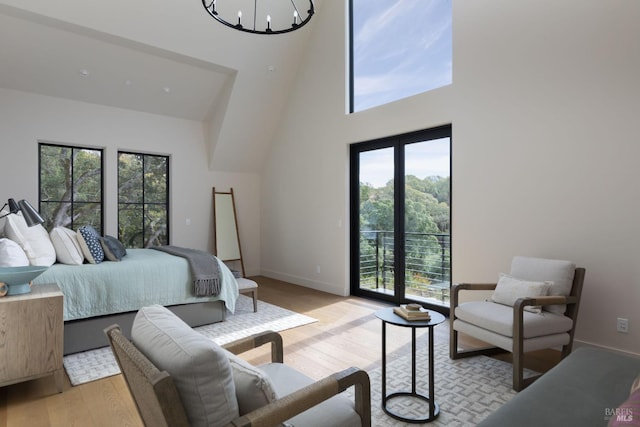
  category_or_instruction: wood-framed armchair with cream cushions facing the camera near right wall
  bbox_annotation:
[449,256,585,391]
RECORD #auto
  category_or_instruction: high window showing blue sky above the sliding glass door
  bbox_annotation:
[349,0,452,113]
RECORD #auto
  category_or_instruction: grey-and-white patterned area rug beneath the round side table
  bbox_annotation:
[347,345,534,427]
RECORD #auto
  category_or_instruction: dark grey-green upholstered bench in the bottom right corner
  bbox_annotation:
[478,347,640,427]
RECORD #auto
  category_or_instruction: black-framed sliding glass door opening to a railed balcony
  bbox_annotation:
[350,126,451,311]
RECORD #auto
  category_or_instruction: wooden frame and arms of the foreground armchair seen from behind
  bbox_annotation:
[105,325,371,427]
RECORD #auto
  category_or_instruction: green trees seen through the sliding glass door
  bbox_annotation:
[360,176,450,290]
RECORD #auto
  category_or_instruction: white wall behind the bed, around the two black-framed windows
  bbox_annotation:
[0,89,260,275]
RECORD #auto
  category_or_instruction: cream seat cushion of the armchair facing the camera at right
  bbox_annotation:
[455,301,573,339]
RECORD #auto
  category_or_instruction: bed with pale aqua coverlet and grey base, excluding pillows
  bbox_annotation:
[33,249,238,354]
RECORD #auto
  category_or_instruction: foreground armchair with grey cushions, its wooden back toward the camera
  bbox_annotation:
[105,306,371,427]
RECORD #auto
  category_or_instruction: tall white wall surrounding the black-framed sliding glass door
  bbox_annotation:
[261,0,640,353]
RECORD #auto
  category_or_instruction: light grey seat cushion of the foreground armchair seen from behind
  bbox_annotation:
[260,363,362,427]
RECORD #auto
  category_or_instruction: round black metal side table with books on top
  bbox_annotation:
[375,307,445,424]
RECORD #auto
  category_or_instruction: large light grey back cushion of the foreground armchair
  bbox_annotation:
[131,305,239,426]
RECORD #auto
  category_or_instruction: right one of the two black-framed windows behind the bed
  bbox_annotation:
[118,152,169,248]
